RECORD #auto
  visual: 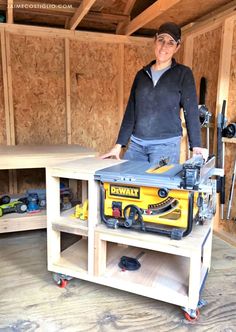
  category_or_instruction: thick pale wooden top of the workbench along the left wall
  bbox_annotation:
[0,144,96,169]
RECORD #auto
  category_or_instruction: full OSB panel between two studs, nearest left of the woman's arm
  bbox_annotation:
[70,41,121,153]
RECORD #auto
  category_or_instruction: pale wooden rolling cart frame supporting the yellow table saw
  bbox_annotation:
[46,158,212,309]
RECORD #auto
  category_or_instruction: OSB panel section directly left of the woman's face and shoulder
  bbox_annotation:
[124,40,155,109]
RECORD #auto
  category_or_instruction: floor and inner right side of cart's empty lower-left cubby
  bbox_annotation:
[53,239,88,274]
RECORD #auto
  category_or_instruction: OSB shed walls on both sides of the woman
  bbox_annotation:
[0,14,236,243]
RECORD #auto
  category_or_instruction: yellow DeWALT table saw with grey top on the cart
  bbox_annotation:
[95,156,222,240]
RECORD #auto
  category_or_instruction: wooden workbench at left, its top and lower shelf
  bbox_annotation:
[0,145,96,233]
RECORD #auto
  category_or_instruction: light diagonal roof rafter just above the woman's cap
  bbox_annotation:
[121,0,182,36]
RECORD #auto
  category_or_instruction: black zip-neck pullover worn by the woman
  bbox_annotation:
[116,59,201,149]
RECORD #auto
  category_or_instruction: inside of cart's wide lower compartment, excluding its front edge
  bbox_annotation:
[104,243,189,295]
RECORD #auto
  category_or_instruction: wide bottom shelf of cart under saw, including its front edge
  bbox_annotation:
[95,243,189,305]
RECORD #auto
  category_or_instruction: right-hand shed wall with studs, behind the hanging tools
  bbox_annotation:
[184,13,236,245]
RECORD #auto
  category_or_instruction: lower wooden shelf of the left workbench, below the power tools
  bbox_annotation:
[0,210,47,233]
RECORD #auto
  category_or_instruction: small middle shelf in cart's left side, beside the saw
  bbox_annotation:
[52,208,88,236]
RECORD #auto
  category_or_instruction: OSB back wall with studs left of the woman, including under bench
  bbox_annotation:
[0,24,152,193]
